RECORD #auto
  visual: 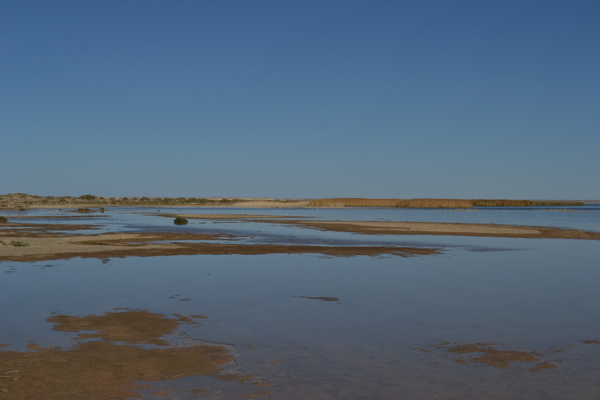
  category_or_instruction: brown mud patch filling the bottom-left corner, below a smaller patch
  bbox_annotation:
[0,341,233,400]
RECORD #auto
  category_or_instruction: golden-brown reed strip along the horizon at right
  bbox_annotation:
[309,198,584,208]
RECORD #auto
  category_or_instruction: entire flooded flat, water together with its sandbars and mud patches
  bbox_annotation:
[0,206,600,400]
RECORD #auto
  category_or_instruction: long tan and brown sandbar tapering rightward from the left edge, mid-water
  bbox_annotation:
[0,232,440,262]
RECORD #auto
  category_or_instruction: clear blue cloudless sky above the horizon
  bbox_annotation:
[0,0,600,199]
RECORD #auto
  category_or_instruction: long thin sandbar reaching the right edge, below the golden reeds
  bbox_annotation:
[169,214,600,240]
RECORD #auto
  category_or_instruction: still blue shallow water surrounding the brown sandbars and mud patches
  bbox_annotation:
[0,206,600,400]
